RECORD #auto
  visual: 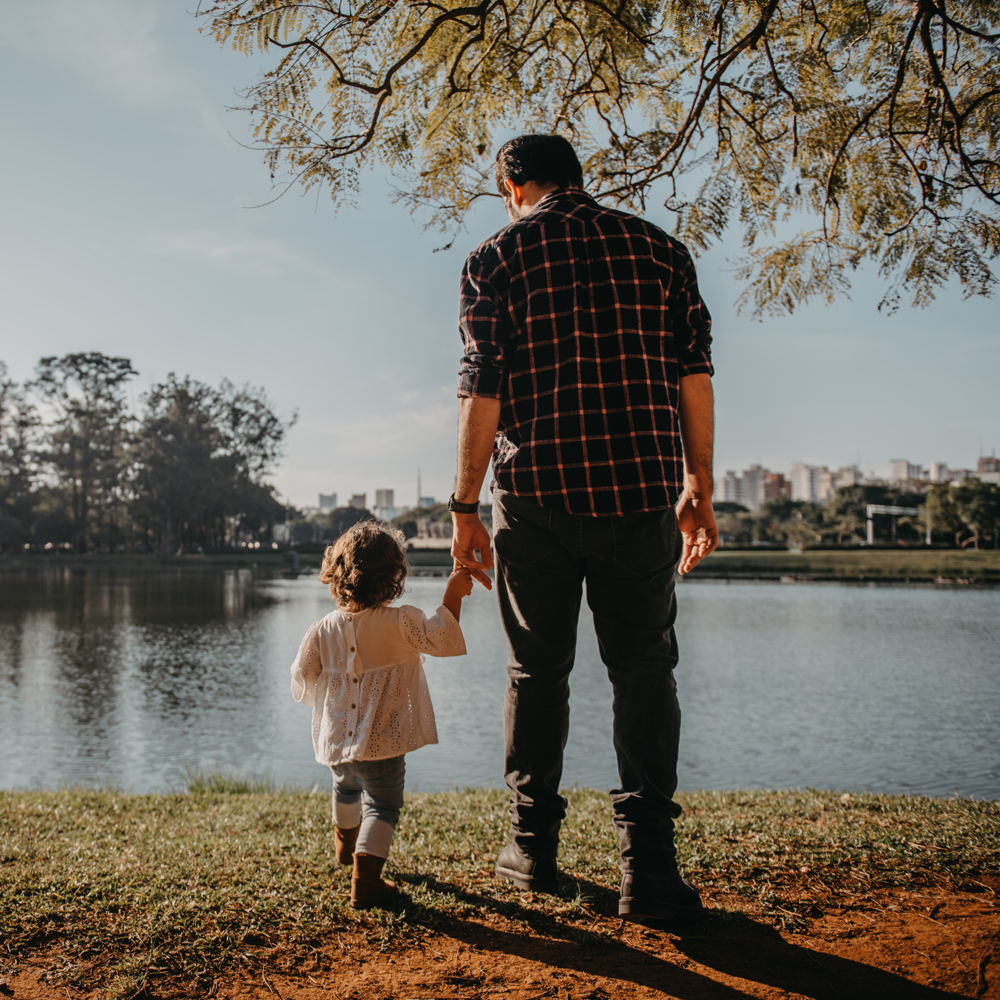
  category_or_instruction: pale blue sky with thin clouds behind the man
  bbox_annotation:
[0,0,1000,506]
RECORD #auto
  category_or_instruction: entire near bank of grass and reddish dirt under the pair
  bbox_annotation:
[0,777,1000,1000]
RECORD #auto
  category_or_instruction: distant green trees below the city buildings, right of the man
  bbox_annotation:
[716,479,1000,548]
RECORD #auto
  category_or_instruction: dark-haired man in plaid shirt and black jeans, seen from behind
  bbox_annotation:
[450,135,717,921]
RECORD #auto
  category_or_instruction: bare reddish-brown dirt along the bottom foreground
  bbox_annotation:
[0,886,1000,1000]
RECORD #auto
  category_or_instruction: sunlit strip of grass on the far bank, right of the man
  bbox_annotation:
[691,547,1000,583]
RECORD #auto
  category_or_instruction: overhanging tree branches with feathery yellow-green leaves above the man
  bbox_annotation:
[200,0,1000,315]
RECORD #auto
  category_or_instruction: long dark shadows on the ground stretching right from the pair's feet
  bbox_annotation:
[397,875,972,1000]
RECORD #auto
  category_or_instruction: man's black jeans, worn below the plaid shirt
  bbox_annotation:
[493,490,681,874]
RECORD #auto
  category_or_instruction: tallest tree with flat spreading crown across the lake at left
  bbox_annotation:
[29,352,138,551]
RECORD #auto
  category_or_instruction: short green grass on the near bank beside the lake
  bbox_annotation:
[0,774,1000,1000]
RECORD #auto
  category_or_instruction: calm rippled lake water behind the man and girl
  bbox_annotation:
[0,568,1000,798]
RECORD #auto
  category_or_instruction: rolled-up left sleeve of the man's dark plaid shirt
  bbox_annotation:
[458,247,508,399]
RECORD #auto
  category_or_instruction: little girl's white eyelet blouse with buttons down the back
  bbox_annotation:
[292,604,465,764]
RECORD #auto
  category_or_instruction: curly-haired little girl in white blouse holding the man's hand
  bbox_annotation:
[292,521,472,909]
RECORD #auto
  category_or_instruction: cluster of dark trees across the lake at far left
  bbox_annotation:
[0,352,295,552]
